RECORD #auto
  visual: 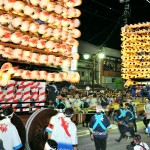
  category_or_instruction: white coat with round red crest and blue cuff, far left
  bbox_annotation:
[0,119,22,150]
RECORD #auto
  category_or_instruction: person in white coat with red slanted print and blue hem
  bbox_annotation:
[46,108,78,150]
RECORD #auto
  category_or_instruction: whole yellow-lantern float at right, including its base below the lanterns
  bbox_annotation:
[121,22,150,113]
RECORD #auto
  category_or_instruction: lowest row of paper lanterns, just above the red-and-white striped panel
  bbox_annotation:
[0,62,80,86]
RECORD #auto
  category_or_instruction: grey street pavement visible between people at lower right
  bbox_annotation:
[77,120,150,150]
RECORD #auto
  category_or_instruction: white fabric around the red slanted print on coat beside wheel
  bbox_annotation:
[50,113,78,145]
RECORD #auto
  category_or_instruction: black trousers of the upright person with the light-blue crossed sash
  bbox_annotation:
[94,137,107,150]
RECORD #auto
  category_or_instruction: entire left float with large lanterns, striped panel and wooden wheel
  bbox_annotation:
[0,0,82,150]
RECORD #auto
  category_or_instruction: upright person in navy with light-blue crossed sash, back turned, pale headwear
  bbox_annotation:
[89,105,110,150]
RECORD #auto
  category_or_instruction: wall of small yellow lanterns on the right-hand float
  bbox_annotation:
[121,22,150,87]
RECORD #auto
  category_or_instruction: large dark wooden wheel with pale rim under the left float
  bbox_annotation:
[25,108,57,150]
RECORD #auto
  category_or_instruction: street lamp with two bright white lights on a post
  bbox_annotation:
[83,51,105,91]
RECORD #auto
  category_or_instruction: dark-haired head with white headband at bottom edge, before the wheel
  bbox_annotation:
[44,139,57,150]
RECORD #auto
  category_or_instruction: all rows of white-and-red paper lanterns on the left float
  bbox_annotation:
[0,0,82,86]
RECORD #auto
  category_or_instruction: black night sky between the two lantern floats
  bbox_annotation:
[77,0,150,50]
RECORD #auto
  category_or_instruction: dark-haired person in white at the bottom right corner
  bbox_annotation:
[127,134,150,150]
